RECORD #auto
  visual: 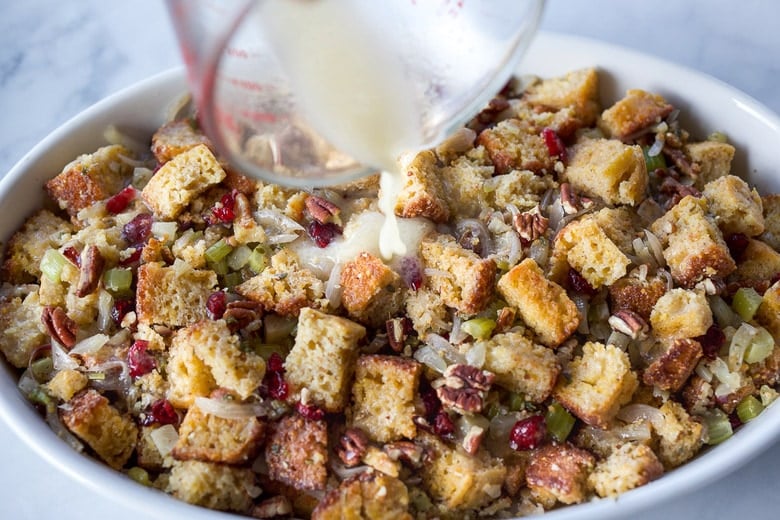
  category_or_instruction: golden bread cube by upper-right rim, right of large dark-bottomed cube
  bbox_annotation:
[702,175,764,237]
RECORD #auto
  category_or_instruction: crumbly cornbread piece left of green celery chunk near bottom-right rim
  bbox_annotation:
[653,400,703,470]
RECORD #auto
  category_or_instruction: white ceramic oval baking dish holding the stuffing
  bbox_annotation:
[0,33,780,520]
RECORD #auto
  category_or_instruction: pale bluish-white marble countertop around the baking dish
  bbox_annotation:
[0,0,780,520]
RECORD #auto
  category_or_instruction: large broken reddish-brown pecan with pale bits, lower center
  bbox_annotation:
[432,364,495,413]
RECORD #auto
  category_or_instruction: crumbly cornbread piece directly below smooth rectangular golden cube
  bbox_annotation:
[483,332,561,403]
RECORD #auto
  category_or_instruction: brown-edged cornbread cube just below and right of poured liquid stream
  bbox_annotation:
[420,233,496,314]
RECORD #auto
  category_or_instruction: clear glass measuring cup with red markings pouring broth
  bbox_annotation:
[167,0,543,187]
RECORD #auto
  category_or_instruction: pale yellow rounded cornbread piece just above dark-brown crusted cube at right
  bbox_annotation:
[650,287,712,339]
